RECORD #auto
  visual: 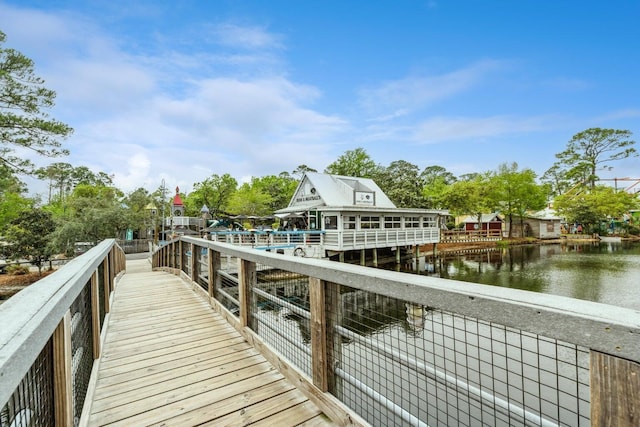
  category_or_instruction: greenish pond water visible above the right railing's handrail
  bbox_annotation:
[390,241,640,310]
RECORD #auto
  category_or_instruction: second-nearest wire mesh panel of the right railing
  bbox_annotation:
[253,264,311,376]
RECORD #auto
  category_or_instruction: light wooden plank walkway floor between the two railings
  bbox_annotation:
[88,260,333,426]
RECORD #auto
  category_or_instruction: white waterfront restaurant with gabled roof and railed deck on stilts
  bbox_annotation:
[275,172,448,257]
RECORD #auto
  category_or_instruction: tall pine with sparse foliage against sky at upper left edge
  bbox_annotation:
[0,31,73,173]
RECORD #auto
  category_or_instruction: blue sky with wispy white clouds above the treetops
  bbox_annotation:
[0,0,640,196]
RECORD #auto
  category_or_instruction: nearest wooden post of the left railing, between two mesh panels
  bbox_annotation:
[52,311,73,426]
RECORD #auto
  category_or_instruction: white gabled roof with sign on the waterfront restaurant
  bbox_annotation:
[281,172,396,212]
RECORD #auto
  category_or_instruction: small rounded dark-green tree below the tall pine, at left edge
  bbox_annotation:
[4,209,55,273]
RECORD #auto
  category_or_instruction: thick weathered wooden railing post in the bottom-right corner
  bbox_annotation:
[590,350,640,427]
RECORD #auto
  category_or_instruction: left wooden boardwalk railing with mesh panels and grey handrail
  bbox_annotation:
[0,240,125,427]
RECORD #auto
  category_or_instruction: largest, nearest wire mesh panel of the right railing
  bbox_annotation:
[327,287,590,426]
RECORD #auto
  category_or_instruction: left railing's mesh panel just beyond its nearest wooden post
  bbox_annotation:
[70,284,93,425]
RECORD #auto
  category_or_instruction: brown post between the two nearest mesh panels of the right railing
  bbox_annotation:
[309,277,330,392]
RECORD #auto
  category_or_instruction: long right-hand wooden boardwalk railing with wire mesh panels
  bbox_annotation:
[153,237,640,426]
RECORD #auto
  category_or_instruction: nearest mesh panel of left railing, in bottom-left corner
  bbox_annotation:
[0,340,54,427]
